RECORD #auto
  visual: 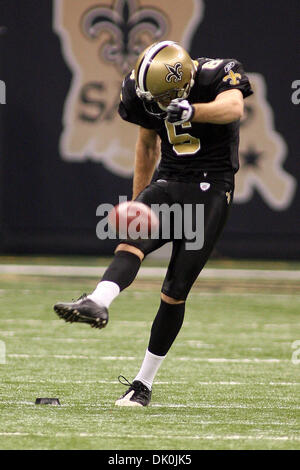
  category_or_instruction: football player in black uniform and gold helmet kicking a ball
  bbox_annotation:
[54,41,252,406]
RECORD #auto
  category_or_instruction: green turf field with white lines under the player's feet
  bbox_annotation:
[0,262,300,450]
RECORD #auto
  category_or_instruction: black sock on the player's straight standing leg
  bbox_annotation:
[148,300,185,356]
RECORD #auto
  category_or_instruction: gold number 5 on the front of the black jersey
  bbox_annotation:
[165,120,201,155]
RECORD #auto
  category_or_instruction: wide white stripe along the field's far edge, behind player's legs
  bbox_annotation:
[0,264,300,281]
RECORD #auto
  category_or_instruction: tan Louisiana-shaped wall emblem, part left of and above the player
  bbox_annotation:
[54,0,204,173]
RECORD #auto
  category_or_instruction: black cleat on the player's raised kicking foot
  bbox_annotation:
[54,294,108,329]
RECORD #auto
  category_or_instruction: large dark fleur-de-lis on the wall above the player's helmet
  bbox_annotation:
[82,0,168,75]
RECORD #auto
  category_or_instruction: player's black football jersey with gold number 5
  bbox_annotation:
[119,58,253,181]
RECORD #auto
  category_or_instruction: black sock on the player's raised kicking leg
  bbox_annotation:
[101,251,141,291]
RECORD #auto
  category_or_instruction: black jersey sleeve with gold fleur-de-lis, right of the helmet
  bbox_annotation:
[212,59,253,98]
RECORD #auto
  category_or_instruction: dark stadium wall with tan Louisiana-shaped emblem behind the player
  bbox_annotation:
[0,0,300,259]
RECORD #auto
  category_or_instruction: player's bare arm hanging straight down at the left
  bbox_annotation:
[132,127,160,199]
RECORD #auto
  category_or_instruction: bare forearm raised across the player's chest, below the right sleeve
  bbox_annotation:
[192,89,244,124]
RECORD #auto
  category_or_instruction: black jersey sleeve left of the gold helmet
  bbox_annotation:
[118,73,154,129]
